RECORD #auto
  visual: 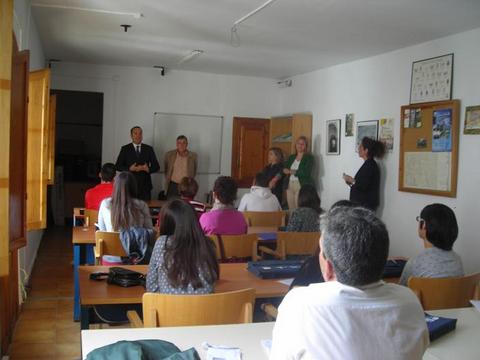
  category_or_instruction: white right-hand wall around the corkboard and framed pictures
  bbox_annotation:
[280,29,480,272]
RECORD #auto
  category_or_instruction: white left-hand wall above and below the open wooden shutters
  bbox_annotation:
[14,0,45,290]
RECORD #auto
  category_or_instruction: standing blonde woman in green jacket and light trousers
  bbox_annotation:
[283,136,313,210]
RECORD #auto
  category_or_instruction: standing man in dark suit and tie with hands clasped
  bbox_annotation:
[115,126,160,200]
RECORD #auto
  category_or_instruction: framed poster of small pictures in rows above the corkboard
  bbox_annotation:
[410,54,453,104]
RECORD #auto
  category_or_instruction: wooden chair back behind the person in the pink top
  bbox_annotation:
[209,234,258,261]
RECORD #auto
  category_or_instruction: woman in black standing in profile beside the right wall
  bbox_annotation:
[343,137,385,211]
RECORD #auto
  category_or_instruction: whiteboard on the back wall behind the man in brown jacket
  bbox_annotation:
[153,112,223,174]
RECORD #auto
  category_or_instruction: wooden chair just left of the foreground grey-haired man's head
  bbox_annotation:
[259,231,320,260]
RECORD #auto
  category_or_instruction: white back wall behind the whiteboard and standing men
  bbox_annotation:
[52,63,280,196]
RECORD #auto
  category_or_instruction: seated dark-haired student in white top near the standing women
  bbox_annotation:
[238,173,282,211]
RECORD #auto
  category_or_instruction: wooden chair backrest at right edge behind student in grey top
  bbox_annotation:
[408,273,480,310]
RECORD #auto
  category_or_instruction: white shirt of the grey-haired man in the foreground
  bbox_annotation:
[270,281,429,360]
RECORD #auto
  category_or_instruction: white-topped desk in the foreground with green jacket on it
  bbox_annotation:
[81,308,480,360]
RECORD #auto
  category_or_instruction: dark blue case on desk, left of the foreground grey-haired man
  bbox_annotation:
[247,260,303,279]
